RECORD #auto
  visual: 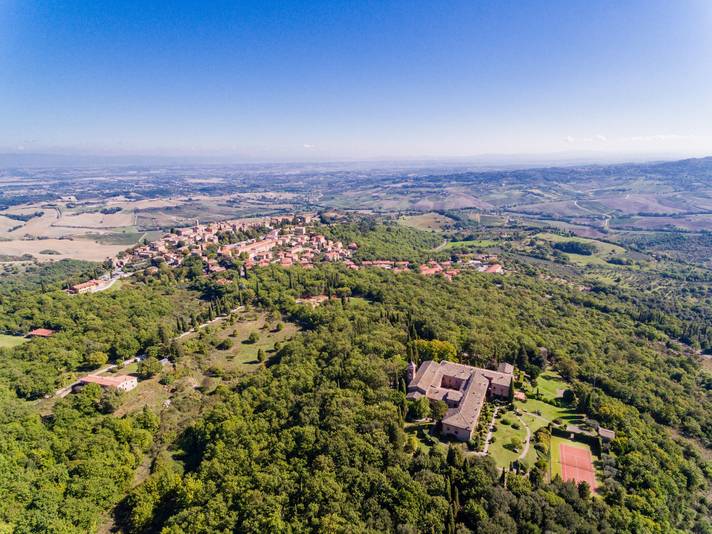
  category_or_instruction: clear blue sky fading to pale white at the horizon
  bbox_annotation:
[0,0,712,160]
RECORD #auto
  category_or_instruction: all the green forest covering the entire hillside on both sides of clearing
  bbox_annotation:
[0,221,712,533]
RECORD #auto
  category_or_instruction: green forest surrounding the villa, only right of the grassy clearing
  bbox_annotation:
[119,268,712,532]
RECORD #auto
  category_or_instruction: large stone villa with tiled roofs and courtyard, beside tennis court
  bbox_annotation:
[407,361,514,441]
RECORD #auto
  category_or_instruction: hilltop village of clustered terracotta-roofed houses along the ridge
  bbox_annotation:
[96,215,504,282]
